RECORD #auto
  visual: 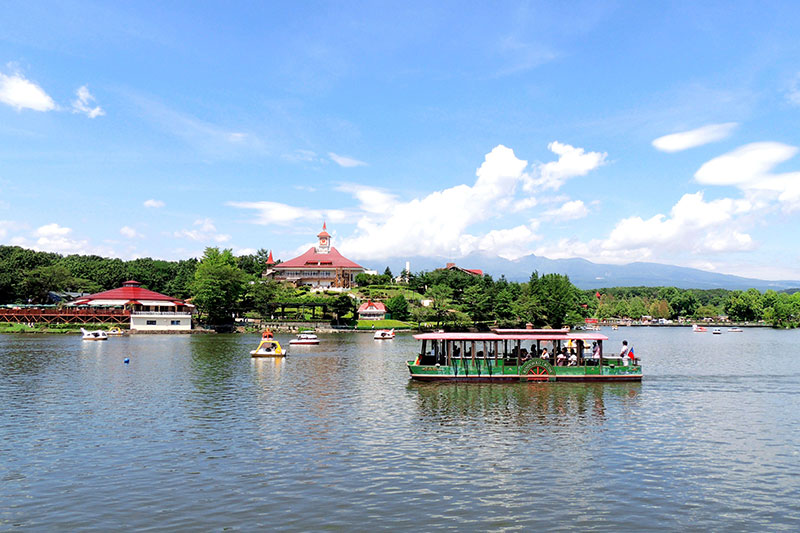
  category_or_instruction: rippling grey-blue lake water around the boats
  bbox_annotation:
[0,328,800,531]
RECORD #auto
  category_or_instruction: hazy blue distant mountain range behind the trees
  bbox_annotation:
[359,254,800,291]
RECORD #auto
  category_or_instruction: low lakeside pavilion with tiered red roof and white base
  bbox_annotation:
[70,280,194,331]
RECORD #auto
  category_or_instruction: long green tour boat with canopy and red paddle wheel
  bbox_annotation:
[407,329,642,382]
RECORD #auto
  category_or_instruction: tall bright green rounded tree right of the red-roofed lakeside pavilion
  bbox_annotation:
[191,248,246,324]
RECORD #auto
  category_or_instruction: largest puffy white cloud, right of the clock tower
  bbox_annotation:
[227,143,606,259]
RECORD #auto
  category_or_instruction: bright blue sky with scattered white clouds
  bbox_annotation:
[0,1,800,279]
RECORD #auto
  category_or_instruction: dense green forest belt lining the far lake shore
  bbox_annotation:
[0,246,800,327]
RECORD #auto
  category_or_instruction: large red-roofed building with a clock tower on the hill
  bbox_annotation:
[264,223,365,288]
